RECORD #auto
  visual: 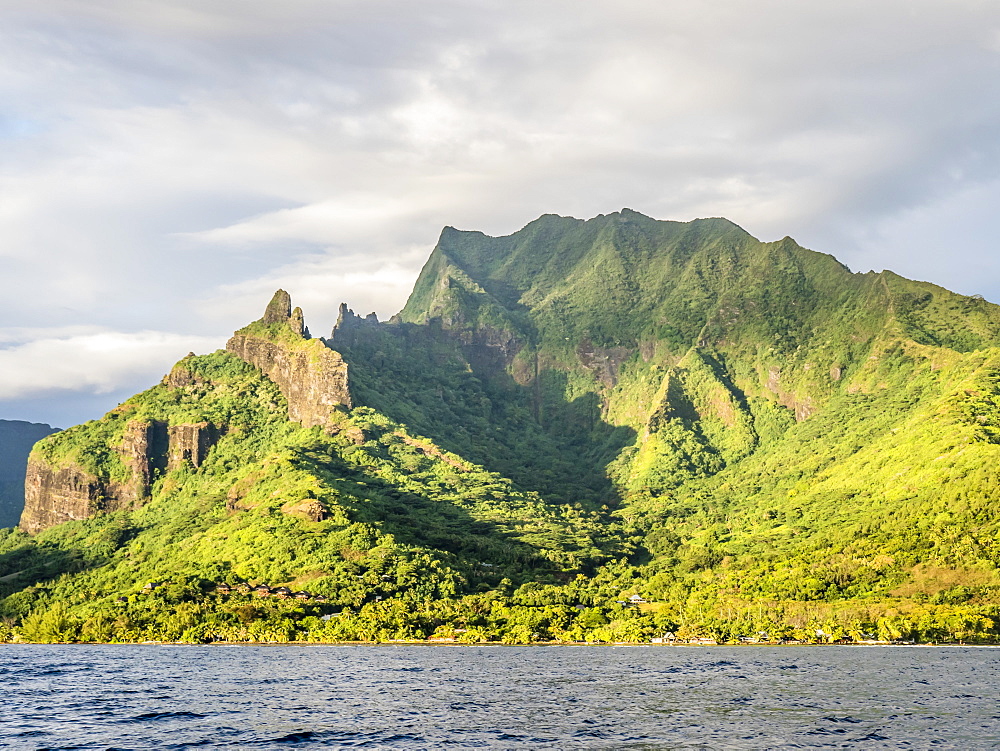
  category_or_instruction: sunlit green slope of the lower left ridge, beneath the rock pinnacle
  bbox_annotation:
[0,302,620,640]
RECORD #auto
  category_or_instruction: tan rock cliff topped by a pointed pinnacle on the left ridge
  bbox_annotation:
[226,290,351,427]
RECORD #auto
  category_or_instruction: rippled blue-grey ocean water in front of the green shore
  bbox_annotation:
[0,645,1000,749]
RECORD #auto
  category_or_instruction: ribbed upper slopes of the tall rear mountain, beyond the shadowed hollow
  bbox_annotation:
[380,211,1000,516]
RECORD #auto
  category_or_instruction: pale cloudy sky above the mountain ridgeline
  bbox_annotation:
[0,0,1000,427]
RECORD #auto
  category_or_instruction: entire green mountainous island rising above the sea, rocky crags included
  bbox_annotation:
[0,210,1000,642]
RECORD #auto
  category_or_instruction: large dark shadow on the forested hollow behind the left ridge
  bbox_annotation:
[330,324,636,509]
